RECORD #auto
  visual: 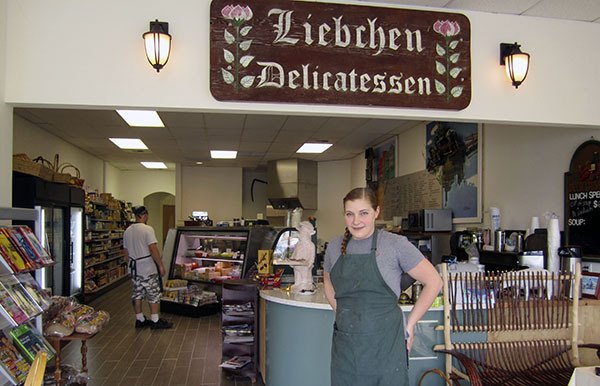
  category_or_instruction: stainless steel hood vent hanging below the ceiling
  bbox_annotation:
[267,158,318,209]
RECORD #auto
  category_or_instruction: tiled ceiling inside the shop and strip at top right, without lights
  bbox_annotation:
[15,0,600,170]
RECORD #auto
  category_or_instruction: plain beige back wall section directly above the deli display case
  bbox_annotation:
[176,166,242,224]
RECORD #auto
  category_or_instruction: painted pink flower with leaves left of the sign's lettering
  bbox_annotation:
[221,4,255,91]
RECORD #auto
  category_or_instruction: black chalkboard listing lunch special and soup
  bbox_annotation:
[564,140,600,257]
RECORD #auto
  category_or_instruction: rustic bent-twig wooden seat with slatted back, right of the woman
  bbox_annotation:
[434,264,600,386]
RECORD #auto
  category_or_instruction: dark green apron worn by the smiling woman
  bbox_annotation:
[330,230,408,386]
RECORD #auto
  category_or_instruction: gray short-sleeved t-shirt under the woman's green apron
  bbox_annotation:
[323,230,425,297]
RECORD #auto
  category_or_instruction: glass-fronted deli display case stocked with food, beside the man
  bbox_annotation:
[161,226,274,316]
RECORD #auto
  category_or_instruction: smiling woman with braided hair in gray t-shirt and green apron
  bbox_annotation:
[324,188,442,386]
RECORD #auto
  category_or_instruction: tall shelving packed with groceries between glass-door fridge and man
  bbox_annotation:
[83,196,128,301]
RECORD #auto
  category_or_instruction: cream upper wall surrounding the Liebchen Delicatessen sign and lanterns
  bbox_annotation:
[5,0,600,126]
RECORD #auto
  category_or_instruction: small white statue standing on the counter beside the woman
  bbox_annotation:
[290,221,316,294]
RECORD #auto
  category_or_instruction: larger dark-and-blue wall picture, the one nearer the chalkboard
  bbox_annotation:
[425,122,483,224]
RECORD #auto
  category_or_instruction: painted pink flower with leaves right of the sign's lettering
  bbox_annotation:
[433,20,464,101]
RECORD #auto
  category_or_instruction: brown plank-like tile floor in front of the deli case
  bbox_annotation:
[62,282,264,386]
